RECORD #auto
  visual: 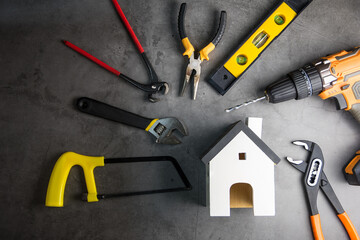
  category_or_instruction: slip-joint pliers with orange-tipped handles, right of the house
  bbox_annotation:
[287,140,360,240]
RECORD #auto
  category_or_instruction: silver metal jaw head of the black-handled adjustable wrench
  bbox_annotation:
[148,118,188,145]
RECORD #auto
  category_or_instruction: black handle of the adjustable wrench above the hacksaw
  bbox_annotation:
[77,97,153,130]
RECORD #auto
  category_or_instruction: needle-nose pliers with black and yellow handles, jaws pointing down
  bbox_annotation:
[178,3,226,100]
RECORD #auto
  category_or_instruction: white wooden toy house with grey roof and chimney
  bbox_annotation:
[201,118,280,216]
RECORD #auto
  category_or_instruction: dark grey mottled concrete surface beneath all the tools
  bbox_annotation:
[0,0,360,239]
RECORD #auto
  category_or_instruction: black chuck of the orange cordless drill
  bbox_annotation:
[265,64,323,103]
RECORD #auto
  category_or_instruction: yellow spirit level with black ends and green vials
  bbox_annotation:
[208,0,312,95]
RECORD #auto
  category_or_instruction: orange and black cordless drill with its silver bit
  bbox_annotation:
[226,47,360,122]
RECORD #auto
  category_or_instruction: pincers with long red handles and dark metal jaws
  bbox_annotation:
[63,0,169,102]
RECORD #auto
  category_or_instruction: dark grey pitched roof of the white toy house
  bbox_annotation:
[201,121,280,164]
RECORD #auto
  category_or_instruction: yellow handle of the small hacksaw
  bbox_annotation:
[45,152,104,207]
